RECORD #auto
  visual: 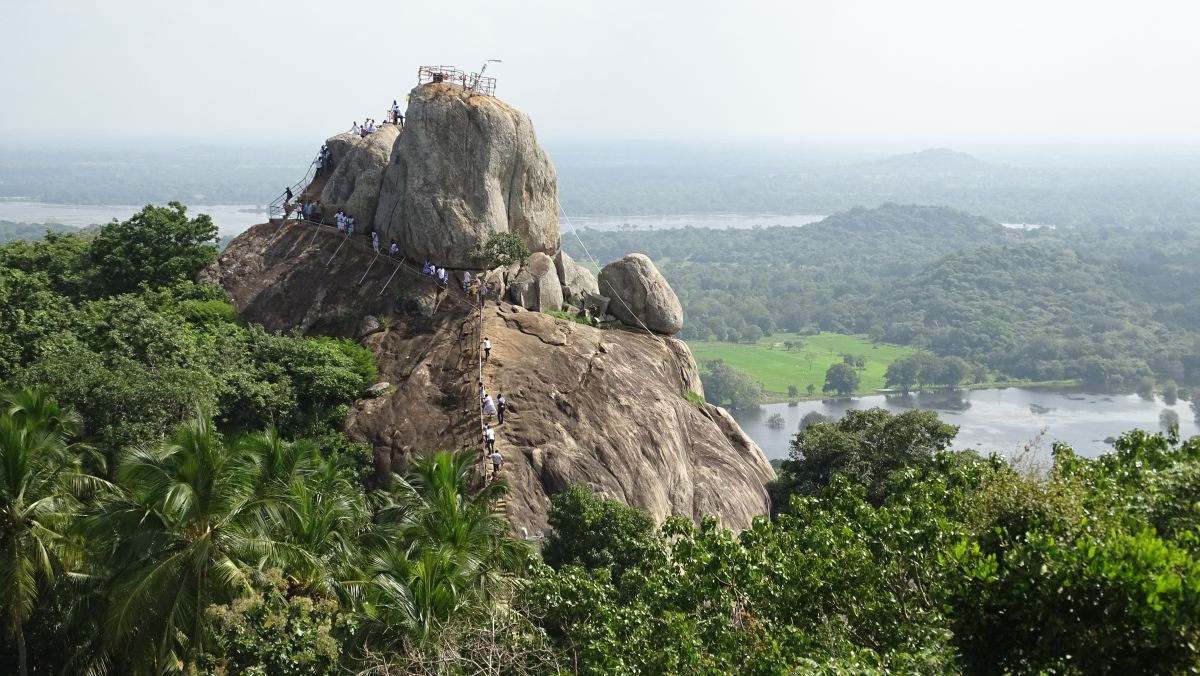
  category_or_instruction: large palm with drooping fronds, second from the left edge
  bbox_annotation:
[84,415,288,672]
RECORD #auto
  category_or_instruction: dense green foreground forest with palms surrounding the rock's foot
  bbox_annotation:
[0,204,1200,675]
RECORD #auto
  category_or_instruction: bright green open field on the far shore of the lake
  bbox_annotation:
[688,334,916,401]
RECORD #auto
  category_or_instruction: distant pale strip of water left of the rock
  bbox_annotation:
[0,199,266,235]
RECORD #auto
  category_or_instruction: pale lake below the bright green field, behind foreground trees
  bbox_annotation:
[732,388,1200,459]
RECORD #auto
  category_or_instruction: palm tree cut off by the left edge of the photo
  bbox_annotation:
[0,389,108,676]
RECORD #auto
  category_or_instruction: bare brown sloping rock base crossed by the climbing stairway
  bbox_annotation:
[205,223,774,532]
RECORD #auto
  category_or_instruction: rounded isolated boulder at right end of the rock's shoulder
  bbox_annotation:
[600,253,683,335]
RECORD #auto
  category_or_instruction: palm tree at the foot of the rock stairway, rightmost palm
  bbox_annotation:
[364,451,529,641]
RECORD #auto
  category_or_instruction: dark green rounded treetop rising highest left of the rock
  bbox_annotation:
[89,202,217,294]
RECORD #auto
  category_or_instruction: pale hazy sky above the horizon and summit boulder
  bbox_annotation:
[0,0,1200,148]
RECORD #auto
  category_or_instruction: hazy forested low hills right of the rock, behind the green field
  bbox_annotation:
[564,204,1200,388]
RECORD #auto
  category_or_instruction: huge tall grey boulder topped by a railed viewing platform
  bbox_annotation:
[373,83,559,268]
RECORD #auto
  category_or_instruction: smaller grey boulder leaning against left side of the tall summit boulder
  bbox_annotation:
[318,125,400,230]
